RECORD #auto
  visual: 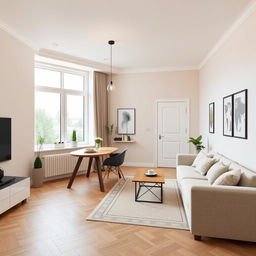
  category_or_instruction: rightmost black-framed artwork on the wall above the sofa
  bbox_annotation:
[233,89,247,139]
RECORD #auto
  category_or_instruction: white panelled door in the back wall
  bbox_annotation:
[157,100,189,167]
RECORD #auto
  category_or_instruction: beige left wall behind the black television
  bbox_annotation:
[0,30,34,176]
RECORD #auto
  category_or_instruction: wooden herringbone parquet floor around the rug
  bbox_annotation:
[0,167,256,256]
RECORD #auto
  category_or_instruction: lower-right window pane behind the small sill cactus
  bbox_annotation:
[67,95,84,141]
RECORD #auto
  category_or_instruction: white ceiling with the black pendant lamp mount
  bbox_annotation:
[0,0,253,70]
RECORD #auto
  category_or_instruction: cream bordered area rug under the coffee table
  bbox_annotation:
[87,177,189,230]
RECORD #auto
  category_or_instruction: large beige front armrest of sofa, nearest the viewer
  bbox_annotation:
[191,186,256,242]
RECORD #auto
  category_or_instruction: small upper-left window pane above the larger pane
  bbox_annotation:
[35,68,60,88]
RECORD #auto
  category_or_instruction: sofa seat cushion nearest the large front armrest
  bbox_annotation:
[180,179,210,209]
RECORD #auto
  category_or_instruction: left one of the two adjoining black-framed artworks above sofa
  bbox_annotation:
[223,95,233,137]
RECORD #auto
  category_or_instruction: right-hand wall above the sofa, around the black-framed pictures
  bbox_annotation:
[200,10,256,170]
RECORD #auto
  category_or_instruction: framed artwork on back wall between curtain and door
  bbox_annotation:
[117,108,136,135]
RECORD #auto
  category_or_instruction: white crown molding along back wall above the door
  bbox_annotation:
[115,66,198,74]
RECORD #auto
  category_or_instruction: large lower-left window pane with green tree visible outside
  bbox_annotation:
[35,92,60,144]
